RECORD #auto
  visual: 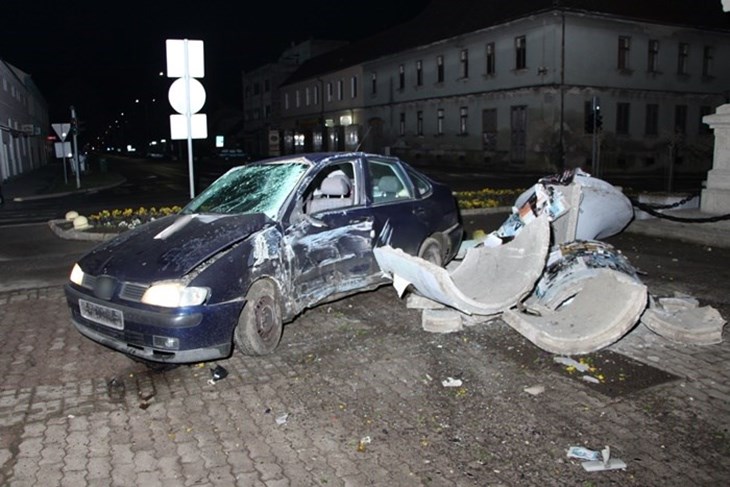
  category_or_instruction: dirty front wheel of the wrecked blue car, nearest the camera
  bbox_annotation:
[234,279,284,355]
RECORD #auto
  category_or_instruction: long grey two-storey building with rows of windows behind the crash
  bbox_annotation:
[280,0,730,173]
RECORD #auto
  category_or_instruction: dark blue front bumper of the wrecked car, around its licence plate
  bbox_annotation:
[65,284,243,364]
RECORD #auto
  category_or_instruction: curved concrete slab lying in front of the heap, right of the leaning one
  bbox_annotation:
[502,269,647,355]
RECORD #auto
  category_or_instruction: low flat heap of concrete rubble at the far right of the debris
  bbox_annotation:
[641,296,727,345]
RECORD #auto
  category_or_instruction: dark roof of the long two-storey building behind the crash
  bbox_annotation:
[284,0,730,84]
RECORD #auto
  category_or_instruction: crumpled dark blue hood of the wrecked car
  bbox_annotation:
[79,213,274,283]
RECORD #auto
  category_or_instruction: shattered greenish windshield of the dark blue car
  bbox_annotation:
[182,162,307,218]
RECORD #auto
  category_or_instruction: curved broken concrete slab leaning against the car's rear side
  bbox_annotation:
[373,215,550,315]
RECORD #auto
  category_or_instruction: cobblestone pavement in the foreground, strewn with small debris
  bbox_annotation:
[0,280,730,487]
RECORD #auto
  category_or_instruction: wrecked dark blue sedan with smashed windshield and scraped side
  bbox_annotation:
[65,152,463,363]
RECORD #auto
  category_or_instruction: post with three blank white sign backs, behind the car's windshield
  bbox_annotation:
[165,39,208,198]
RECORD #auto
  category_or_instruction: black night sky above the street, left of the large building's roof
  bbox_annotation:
[0,0,429,132]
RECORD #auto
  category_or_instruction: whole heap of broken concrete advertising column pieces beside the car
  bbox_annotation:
[374,170,725,355]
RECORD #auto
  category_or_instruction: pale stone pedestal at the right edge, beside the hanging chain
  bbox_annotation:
[700,104,730,215]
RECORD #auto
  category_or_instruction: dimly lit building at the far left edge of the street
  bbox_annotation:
[0,59,50,181]
